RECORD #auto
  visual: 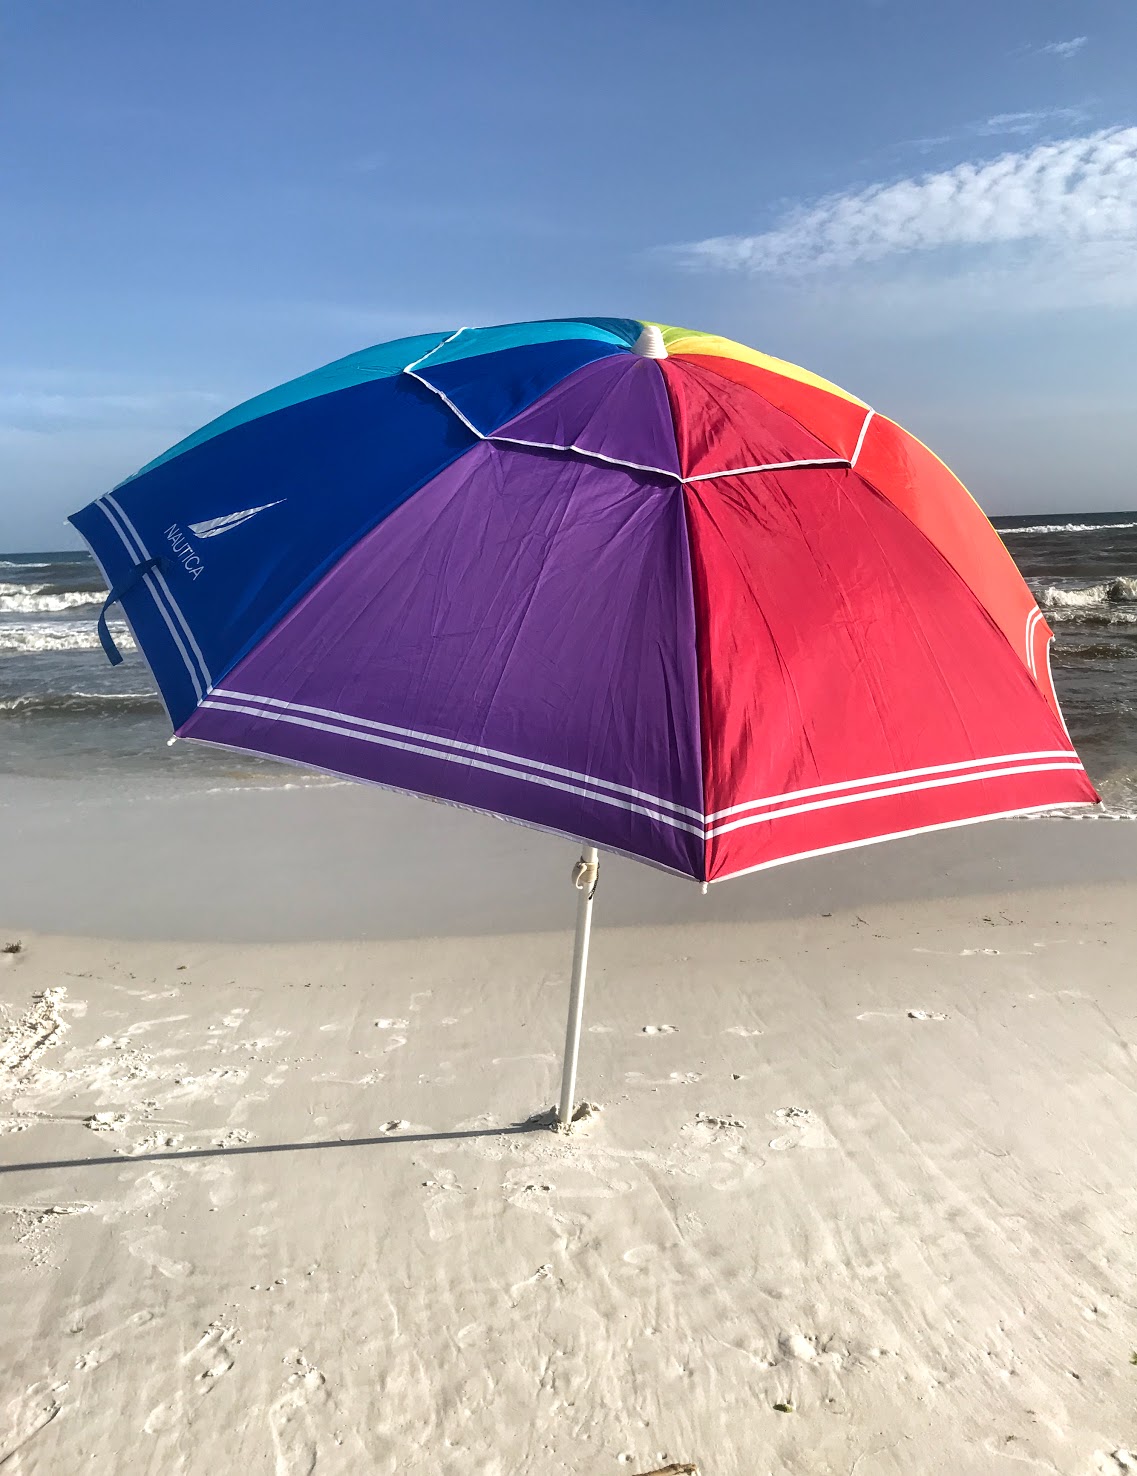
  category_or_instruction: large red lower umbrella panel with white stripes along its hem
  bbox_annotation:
[685,468,1096,880]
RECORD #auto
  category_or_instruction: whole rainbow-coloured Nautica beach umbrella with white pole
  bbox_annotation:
[71,317,1097,1122]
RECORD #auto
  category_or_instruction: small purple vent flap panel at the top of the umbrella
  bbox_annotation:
[493,354,679,477]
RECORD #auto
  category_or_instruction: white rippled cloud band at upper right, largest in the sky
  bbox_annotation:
[670,128,1137,276]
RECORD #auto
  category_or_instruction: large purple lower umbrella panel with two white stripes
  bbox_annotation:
[180,443,704,877]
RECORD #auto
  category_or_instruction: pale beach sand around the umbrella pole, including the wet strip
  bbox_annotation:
[0,790,1137,1476]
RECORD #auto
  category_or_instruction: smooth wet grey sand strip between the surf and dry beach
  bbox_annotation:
[0,779,1137,943]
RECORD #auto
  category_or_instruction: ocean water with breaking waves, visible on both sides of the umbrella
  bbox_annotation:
[0,512,1137,818]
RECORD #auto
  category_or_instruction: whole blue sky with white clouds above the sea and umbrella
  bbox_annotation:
[0,0,1137,549]
